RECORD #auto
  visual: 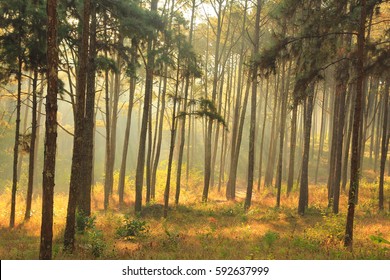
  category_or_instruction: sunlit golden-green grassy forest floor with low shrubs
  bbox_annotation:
[0,175,390,259]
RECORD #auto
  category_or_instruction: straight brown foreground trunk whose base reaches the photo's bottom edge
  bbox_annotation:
[39,0,58,260]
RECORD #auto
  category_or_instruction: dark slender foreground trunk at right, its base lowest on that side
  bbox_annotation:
[344,0,367,249]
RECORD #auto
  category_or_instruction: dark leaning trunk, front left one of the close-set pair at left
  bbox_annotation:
[64,0,91,252]
